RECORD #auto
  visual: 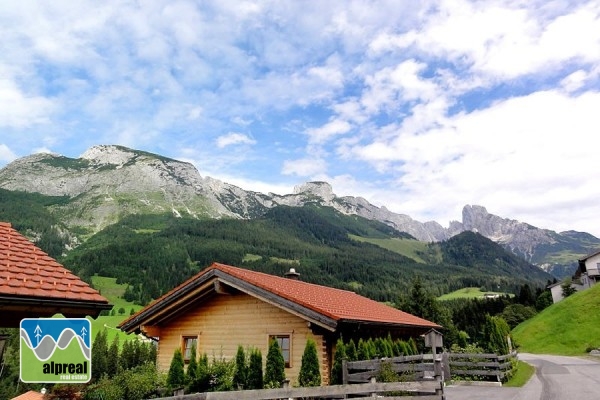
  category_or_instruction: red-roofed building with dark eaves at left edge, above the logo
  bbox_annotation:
[0,222,112,327]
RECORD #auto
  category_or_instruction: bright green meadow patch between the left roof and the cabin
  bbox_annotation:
[92,276,142,345]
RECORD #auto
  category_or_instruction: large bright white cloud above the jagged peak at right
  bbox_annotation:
[346,91,600,232]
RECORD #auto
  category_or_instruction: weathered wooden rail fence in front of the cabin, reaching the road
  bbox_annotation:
[150,352,517,400]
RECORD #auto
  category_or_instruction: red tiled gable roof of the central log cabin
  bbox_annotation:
[119,263,440,330]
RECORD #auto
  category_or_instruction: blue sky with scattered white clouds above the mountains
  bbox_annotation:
[0,0,600,237]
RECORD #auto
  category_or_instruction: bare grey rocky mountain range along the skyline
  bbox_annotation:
[0,145,600,276]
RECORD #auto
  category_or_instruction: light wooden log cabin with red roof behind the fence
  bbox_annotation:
[119,263,440,384]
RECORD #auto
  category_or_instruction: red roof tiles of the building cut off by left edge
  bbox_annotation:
[0,222,108,304]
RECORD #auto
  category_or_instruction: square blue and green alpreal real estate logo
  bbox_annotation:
[20,318,92,383]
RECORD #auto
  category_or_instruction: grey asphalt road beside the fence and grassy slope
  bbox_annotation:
[445,354,600,400]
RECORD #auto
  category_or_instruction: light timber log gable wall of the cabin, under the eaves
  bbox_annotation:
[157,292,331,385]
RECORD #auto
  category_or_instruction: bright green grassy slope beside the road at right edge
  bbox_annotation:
[513,285,600,356]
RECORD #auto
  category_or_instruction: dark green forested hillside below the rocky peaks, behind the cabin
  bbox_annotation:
[62,206,550,304]
